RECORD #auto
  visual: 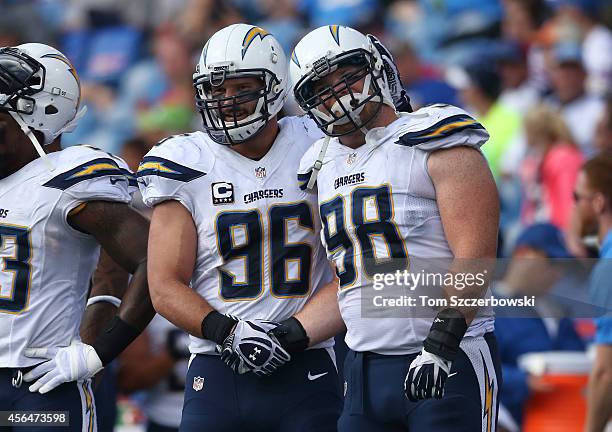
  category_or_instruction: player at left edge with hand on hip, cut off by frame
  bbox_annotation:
[0,43,154,431]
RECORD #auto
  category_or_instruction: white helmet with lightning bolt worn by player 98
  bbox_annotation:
[289,25,395,136]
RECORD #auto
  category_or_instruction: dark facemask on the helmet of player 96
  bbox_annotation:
[194,69,283,145]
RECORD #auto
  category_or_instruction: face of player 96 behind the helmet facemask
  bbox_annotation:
[210,77,264,124]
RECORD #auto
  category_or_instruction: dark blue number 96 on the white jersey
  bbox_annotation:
[216,202,314,301]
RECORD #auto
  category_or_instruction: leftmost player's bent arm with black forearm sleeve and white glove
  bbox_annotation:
[24,201,155,393]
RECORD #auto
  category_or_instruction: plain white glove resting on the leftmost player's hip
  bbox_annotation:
[23,340,104,394]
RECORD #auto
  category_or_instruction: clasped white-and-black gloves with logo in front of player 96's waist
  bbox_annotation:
[220,320,291,376]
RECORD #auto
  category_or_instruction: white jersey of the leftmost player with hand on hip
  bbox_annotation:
[0,146,135,368]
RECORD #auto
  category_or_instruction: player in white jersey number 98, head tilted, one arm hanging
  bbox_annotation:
[290,25,499,432]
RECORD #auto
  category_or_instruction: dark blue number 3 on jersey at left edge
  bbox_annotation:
[0,224,32,314]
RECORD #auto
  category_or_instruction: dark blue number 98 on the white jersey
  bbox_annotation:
[320,185,408,289]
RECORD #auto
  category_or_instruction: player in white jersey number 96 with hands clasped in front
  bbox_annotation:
[138,24,344,432]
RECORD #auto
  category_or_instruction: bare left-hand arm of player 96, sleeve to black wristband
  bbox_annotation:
[149,201,222,337]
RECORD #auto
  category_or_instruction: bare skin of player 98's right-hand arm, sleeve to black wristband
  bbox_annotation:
[428,147,499,324]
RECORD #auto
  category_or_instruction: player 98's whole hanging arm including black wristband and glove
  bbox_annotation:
[404,147,499,402]
